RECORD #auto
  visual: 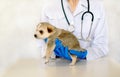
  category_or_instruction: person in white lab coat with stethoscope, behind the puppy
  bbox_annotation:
[40,0,108,60]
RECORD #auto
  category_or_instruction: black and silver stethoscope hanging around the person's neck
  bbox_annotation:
[61,0,94,42]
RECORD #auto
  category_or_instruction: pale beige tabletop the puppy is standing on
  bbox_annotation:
[3,58,120,77]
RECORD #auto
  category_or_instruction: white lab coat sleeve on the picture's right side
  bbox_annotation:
[87,3,108,60]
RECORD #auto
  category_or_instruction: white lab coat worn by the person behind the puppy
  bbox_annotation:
[40,0,108,60]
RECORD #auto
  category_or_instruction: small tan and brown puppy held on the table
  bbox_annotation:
[34,22,84,65]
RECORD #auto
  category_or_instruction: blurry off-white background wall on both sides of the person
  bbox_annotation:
[0,0,120,74]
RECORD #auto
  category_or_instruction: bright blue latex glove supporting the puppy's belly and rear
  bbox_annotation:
[54,39,87,60]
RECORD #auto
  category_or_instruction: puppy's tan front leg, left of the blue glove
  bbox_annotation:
[45,41,55,64]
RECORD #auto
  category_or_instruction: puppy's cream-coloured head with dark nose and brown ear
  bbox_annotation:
[34,22,55,39]
